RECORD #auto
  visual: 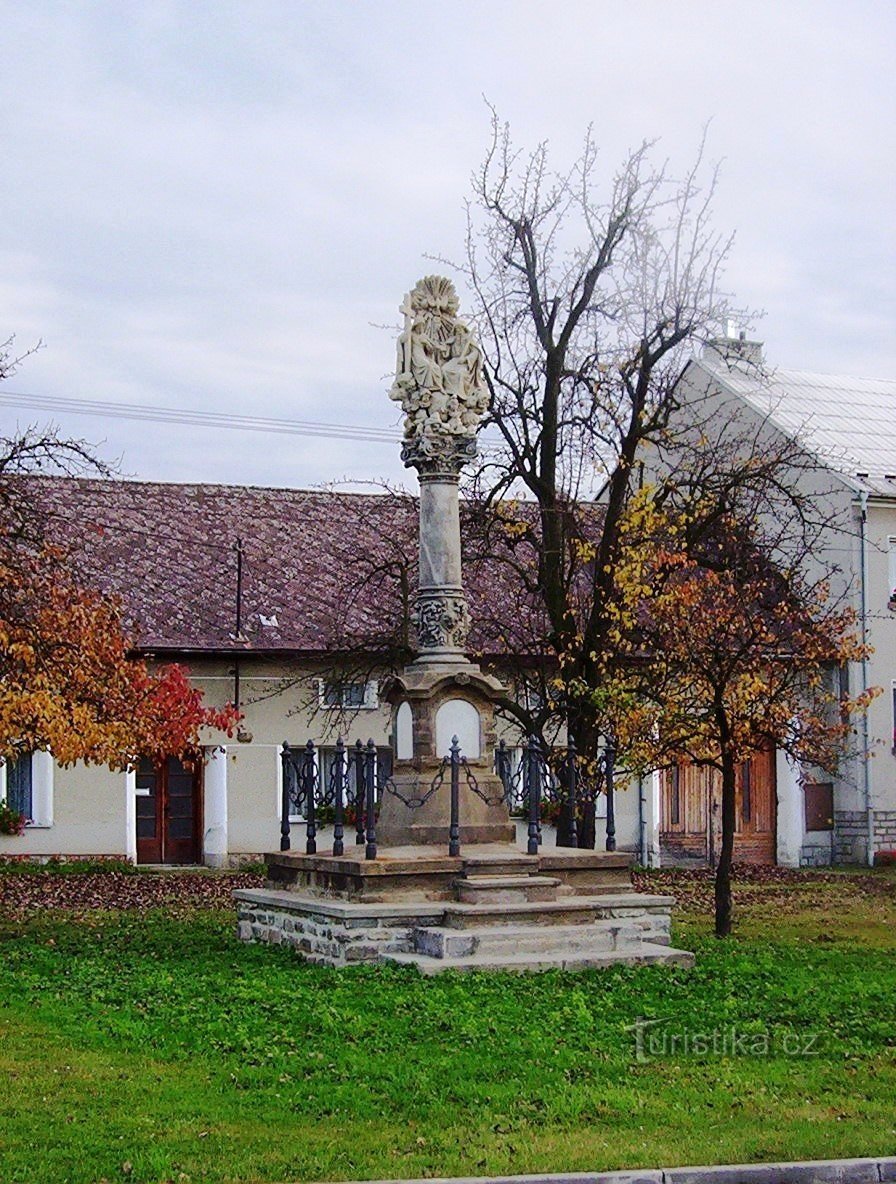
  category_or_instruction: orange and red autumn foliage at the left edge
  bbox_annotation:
[0,535,238,768]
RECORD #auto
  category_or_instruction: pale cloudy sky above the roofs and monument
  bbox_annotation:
[0,0,896,488]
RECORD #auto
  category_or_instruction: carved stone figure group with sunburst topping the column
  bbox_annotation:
[389,276,489,464]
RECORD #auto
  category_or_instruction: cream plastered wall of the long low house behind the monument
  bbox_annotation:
[0,659,640,866]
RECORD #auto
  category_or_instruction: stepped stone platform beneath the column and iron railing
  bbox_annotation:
[234,843,694,974]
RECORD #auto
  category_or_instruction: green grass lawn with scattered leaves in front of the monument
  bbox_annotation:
[0,873,896,1184]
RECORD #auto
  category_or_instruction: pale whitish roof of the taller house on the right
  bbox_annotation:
[700,355,896,497]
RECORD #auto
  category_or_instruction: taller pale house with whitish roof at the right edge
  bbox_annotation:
[647,341,896,867]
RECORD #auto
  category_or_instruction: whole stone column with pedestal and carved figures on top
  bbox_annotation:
[379,276,516,847]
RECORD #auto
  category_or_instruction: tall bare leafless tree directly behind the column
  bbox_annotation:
[449,112,731,795]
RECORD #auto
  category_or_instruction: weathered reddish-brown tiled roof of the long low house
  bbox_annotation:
[26,477,542,654]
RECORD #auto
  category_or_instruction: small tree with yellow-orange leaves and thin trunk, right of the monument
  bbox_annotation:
[594,489,878,937]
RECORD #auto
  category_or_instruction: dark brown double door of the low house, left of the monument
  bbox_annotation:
[137,757,201,863]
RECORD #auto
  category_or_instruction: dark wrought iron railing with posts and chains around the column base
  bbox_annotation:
[281,736,615,860]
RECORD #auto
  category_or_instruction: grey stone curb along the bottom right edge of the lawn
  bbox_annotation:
[333,1157,896,1184]
